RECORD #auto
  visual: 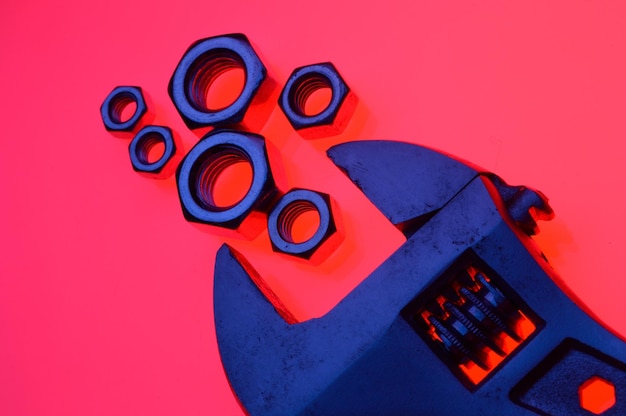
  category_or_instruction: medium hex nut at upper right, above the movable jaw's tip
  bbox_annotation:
[278,62,357,139]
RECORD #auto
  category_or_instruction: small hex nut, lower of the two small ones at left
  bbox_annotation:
[128,126,176,178]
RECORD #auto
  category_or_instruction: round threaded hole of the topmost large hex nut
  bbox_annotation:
[185,49,246,112]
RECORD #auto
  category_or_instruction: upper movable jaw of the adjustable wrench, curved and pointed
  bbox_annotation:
[327,140,478,236]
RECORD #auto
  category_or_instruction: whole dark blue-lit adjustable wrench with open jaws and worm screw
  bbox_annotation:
[214,141,626,416]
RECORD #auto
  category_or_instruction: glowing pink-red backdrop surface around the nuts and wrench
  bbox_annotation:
[0,0,626,415]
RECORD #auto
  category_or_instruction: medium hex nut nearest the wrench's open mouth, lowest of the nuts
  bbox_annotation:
[267,189,342,263]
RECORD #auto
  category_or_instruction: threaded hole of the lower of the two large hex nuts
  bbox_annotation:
[191,147,254,211]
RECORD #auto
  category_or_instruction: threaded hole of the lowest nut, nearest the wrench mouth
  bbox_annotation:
[278,201,320,244]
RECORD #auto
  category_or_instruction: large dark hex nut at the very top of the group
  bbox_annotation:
[168,34,267,129]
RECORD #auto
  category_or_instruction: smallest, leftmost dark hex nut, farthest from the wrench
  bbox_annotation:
[100,86,148,132]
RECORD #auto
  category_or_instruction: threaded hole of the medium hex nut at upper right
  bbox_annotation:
[289,74,333,117]
